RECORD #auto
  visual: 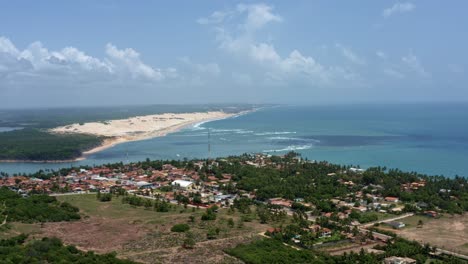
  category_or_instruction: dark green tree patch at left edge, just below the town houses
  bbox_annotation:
[0,187,80,223]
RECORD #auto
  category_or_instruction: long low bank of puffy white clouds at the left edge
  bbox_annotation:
[0,37,177,86]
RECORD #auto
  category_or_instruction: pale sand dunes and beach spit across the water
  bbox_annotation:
[49,111,239,160]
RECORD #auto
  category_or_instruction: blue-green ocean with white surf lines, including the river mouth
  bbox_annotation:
[0,103,468,177]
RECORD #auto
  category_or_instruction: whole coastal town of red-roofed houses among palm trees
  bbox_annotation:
[0,153,461,263]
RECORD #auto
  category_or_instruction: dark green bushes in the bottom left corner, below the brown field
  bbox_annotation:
[0,235,135,264]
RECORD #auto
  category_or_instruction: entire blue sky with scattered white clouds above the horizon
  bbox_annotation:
[0,0,468,107]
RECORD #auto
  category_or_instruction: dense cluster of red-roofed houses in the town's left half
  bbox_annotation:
[0,162,239,206]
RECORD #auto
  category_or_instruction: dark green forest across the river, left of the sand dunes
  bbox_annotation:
[0,129,103,160]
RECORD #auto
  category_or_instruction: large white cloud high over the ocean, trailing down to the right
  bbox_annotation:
[199,4,354,85]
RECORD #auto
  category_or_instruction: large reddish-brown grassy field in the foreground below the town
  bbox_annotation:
[0,194,270,263]
